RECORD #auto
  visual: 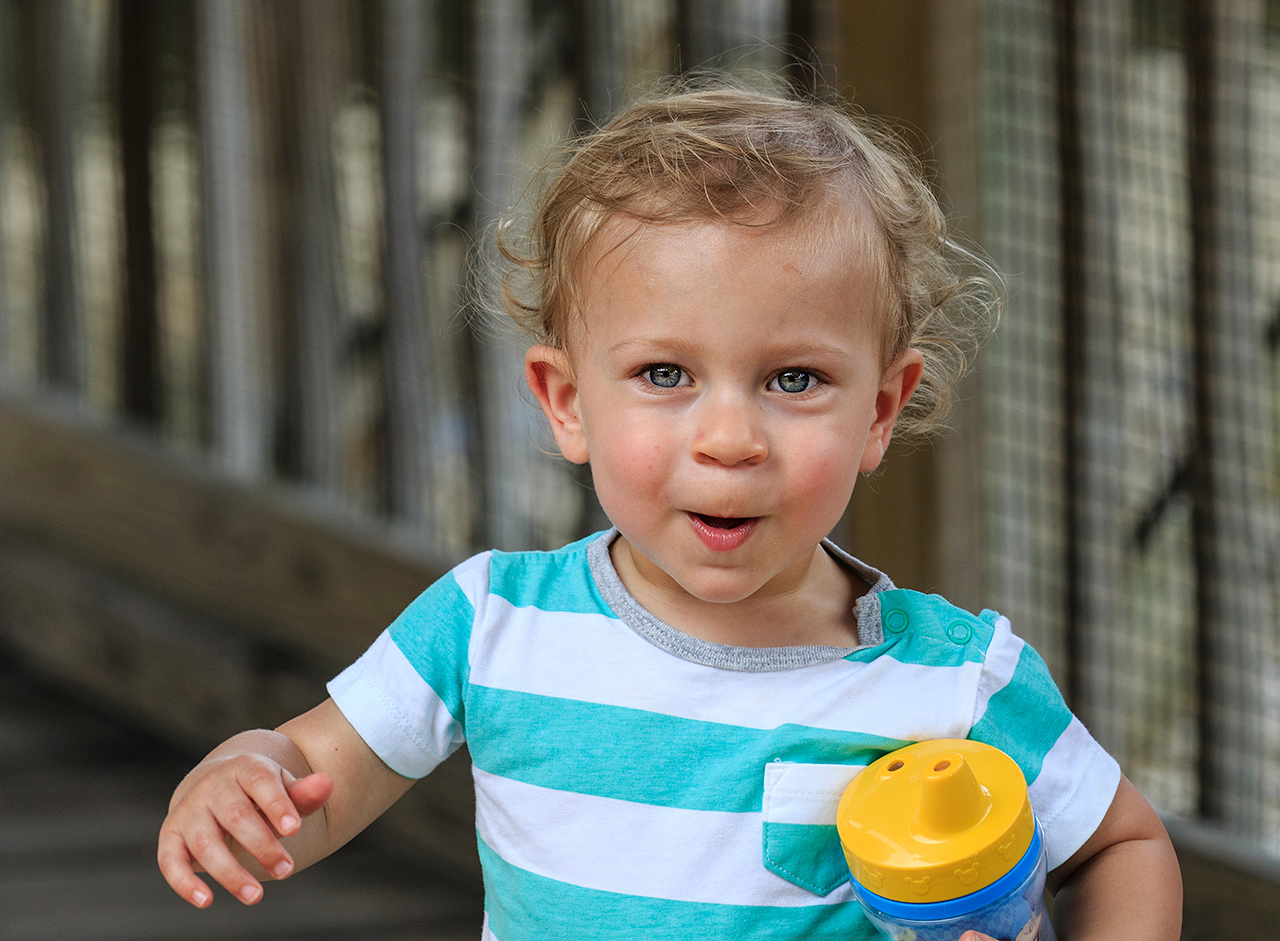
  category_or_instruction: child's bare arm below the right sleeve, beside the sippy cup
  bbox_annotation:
[961,777,1183,941]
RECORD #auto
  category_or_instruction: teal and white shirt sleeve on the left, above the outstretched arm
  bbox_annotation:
[328,557,488,778]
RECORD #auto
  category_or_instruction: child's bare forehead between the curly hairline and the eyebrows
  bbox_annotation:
[564,204,886,361]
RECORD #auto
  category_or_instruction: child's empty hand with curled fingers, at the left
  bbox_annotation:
[156,753,333,908]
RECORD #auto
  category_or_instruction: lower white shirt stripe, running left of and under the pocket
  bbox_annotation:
[475,769,852,906]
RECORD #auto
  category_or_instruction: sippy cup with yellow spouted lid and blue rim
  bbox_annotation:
[836,739,1056,941]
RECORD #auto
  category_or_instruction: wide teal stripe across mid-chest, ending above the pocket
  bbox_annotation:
[467,685,908,813]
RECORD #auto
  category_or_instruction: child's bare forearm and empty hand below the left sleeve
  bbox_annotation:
[157,700,413,908]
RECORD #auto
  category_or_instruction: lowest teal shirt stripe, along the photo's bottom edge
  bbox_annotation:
[477,839,876,941]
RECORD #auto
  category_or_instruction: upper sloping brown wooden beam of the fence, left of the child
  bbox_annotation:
[0,393,448,664]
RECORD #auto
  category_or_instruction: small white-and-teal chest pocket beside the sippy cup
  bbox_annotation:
[762,762,864,896]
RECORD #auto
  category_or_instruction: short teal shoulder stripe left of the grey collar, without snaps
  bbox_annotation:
[489,536,614,617]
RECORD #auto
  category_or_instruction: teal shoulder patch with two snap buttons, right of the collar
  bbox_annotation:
[870,589,995,667]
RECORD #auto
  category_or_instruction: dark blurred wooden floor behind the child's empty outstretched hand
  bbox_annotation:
[0,664,481,941]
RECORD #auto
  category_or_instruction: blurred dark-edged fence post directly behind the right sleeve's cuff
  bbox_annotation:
[1059,0,1132,742]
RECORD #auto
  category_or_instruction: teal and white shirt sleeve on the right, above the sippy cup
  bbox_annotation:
[969,617,1120,869]
